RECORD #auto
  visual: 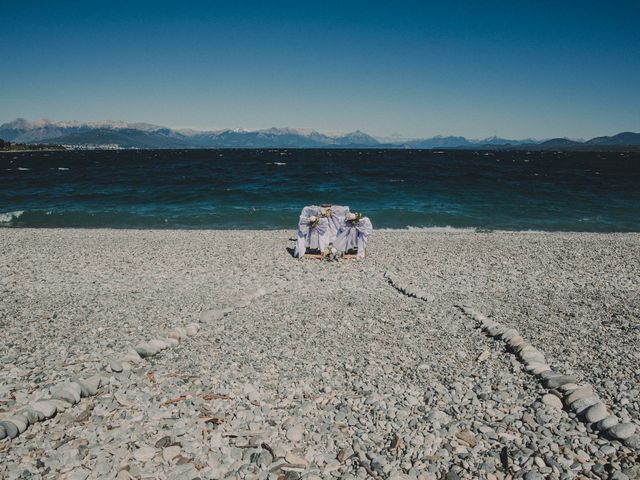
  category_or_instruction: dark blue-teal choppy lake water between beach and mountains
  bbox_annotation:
[0,150,640,232]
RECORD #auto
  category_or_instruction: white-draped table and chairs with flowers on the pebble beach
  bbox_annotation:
[294,204,373,260]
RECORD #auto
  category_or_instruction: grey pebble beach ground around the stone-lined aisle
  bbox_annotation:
[0,229,640,480]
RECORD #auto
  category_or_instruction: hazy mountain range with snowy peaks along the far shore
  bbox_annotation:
[0,118,640,150]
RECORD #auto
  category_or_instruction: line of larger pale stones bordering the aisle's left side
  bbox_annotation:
[0,289,270,440]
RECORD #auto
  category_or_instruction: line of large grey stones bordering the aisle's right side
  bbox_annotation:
[385,272,640,449]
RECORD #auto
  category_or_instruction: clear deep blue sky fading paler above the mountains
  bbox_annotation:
[0,0,640,138]
